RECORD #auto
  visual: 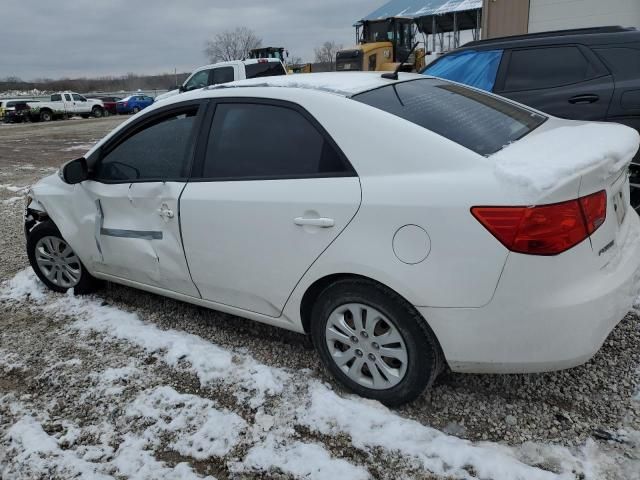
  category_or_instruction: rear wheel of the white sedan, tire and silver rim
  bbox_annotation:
[311,279,442,406]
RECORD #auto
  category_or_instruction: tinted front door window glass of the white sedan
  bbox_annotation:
[92,107,197,183]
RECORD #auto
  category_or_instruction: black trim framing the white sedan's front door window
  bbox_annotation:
[89,99,209,185]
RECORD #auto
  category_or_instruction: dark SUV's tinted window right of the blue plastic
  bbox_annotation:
[504,46,595,92]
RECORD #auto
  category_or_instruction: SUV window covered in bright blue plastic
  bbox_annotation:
[422,50,503,92]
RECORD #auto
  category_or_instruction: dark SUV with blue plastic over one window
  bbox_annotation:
[422,27,640,211]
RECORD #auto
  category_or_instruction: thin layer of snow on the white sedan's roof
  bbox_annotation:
[208,72,425,96]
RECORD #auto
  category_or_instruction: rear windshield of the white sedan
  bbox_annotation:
[352,78,547,155]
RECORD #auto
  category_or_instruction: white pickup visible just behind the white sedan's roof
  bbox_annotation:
[156,58,287,101]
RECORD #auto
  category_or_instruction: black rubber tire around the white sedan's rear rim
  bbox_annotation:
[311,279,443,407]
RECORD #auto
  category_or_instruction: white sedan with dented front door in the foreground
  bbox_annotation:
[25,73,640,405]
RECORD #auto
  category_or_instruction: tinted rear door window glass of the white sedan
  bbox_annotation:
[203,103,353,180]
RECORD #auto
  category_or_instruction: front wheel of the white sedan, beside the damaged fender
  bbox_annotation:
[27,220,99,294]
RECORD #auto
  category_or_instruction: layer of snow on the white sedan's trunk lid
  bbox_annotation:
[491,123,640,193]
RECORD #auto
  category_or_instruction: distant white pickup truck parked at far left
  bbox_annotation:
[28,92,104,122]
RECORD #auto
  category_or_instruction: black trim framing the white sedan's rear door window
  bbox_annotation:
[189,97,358,183]
